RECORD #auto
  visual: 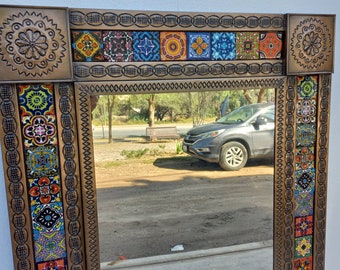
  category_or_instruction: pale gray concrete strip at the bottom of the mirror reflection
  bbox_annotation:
[101,241,273,270]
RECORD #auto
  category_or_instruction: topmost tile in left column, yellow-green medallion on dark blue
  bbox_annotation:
[18,84,54,117]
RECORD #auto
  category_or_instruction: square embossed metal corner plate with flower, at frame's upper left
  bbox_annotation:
[0,6,72,82]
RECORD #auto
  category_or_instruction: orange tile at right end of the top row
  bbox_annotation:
[260,32,282,59]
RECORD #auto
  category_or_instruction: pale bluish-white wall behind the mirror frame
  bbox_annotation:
[0,0,340,270]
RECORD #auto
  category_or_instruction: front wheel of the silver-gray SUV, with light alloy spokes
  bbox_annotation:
[219,142,248,171]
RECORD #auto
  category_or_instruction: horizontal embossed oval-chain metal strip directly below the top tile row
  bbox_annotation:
[73,59,285,82]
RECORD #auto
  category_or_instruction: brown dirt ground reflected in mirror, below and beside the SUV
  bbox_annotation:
[94,139,273,262]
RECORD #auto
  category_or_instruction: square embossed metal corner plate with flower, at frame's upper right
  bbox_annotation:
[287,14,335,75]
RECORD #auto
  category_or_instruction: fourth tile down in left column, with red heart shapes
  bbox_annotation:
[28,176,61,206]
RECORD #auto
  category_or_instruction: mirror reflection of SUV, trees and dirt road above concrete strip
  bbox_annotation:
[91,89,275,262]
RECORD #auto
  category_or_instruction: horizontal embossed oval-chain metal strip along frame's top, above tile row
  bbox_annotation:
[70,9,285,31]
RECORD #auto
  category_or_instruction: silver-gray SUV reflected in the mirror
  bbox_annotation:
[182,103,275,171]
